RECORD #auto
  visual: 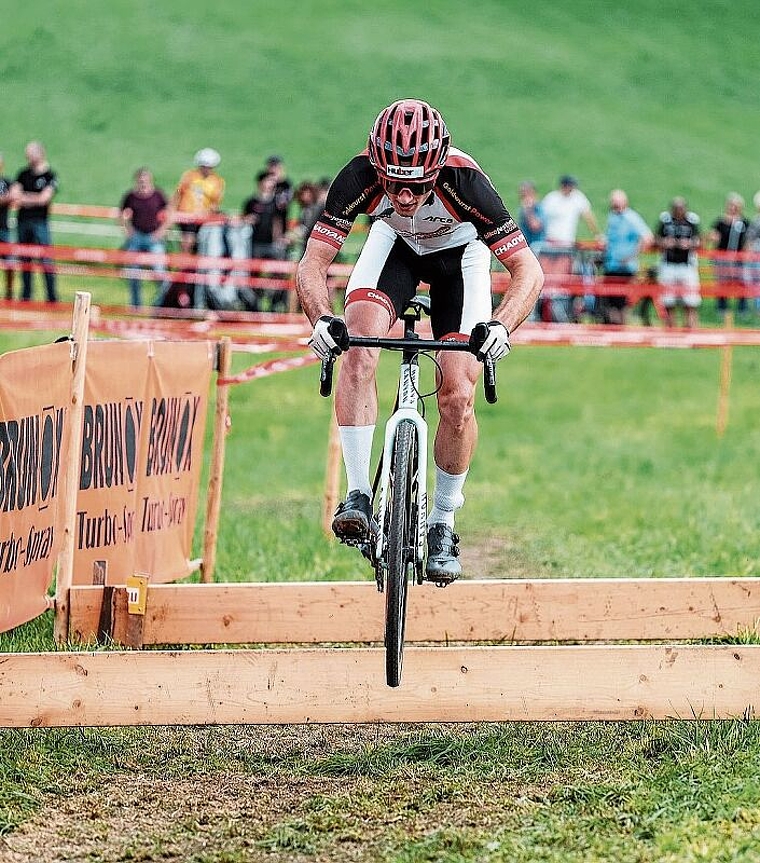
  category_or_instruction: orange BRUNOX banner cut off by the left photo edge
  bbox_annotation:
[0,343,72,632]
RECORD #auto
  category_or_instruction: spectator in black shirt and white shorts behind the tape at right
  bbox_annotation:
[655,197,702,329]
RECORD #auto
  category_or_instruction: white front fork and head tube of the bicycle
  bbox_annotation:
[375,355,428,565]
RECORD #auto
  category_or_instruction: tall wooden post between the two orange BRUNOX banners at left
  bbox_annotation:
[54,291,91,644]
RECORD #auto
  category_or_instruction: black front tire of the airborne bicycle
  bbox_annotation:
[385,420,418,686]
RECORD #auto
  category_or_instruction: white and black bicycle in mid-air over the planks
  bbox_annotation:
[319,295,497,687]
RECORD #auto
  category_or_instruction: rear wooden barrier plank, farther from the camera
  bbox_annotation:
[71,578,760,644]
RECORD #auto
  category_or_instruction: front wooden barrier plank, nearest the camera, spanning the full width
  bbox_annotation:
[0,645,760,727]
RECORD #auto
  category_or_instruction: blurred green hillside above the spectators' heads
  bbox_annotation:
[0,0,760,226]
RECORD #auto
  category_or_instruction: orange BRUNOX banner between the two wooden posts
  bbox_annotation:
[73,341,215,584]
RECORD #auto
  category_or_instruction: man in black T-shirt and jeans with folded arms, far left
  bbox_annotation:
[11,141,58,303]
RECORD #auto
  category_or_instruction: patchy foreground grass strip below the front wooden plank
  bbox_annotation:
[0,722,760,863]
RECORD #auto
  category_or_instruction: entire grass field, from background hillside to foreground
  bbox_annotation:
[0,0,760,863]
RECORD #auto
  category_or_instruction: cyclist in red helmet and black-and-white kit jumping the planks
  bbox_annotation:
[296,99,543,583]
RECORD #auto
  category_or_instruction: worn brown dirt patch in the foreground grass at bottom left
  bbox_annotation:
[0,774,524,863]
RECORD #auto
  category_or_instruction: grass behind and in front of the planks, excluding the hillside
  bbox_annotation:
[0,326,760,863]
